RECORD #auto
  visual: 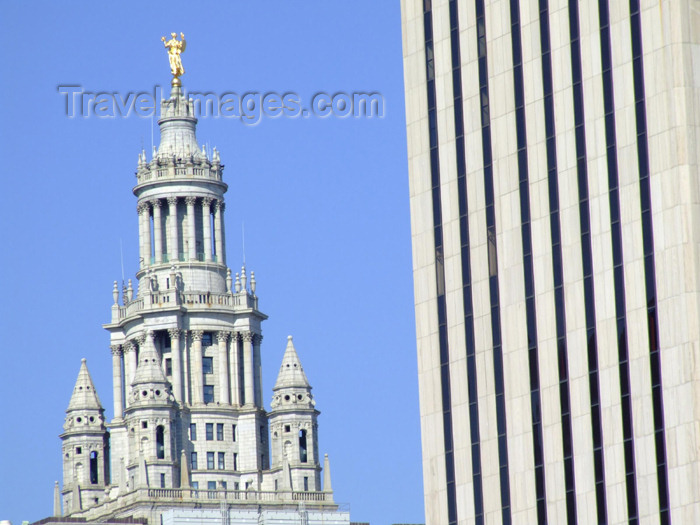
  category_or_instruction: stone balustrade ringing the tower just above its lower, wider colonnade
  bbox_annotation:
[112,289,258,323]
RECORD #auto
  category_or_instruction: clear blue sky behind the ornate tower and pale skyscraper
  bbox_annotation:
[0,0,424,525]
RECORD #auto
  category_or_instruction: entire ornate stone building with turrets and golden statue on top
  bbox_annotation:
[44,44,349,525]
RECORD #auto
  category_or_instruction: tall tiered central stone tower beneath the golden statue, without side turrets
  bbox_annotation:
[105,72,269,496]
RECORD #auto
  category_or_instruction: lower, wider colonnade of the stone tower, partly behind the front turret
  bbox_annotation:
[111,328,263,418]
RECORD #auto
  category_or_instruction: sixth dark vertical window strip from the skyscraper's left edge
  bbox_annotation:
[569,0,608,524]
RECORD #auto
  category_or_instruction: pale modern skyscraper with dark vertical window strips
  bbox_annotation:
[401,0,700,525]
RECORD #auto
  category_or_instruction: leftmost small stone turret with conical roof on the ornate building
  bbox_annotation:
[61,359,109,512]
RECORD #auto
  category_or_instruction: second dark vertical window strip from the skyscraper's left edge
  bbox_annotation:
[450,0,484,525]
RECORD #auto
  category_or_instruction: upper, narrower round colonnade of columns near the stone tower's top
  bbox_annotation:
[137,196,226,268]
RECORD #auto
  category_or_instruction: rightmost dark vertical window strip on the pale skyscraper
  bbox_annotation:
[630,0,671,525]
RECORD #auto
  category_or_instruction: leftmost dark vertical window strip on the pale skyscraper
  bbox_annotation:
[423,0,457,525]
